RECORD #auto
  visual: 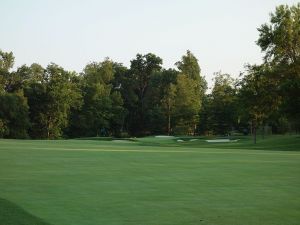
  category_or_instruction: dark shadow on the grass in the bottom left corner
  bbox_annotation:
[0,198,50,225]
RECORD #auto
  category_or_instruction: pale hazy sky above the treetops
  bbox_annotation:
[0,0,297,88]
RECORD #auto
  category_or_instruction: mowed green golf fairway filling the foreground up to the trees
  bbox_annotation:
[0,136,300,225]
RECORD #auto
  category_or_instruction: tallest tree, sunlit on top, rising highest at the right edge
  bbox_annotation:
[257,3,300,129]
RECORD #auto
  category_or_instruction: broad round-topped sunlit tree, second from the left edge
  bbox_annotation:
[25,64,81,139]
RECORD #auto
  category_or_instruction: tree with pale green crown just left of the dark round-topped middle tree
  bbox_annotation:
[71,59,125,136]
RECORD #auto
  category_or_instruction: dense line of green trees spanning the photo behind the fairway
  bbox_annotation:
[0,4,300,139]
